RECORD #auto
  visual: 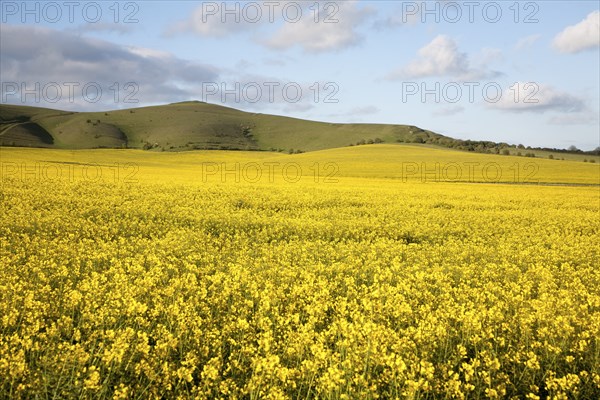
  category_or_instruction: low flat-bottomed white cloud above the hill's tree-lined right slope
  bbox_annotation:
[486,82,586,113]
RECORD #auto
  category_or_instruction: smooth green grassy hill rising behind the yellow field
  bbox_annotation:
[0,101,444,152]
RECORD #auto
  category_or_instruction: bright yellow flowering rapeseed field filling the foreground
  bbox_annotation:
[0,145,600,399]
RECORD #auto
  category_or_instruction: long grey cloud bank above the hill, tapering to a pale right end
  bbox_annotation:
[0,25,326,112]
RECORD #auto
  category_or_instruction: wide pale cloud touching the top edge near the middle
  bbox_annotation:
[166,0,374,52]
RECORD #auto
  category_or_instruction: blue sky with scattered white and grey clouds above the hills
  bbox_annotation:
[0,0,600,149]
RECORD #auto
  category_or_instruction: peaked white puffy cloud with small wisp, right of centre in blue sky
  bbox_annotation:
[388,35,501,80]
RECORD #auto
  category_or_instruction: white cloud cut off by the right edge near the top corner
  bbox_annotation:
[553,11,600,53]
